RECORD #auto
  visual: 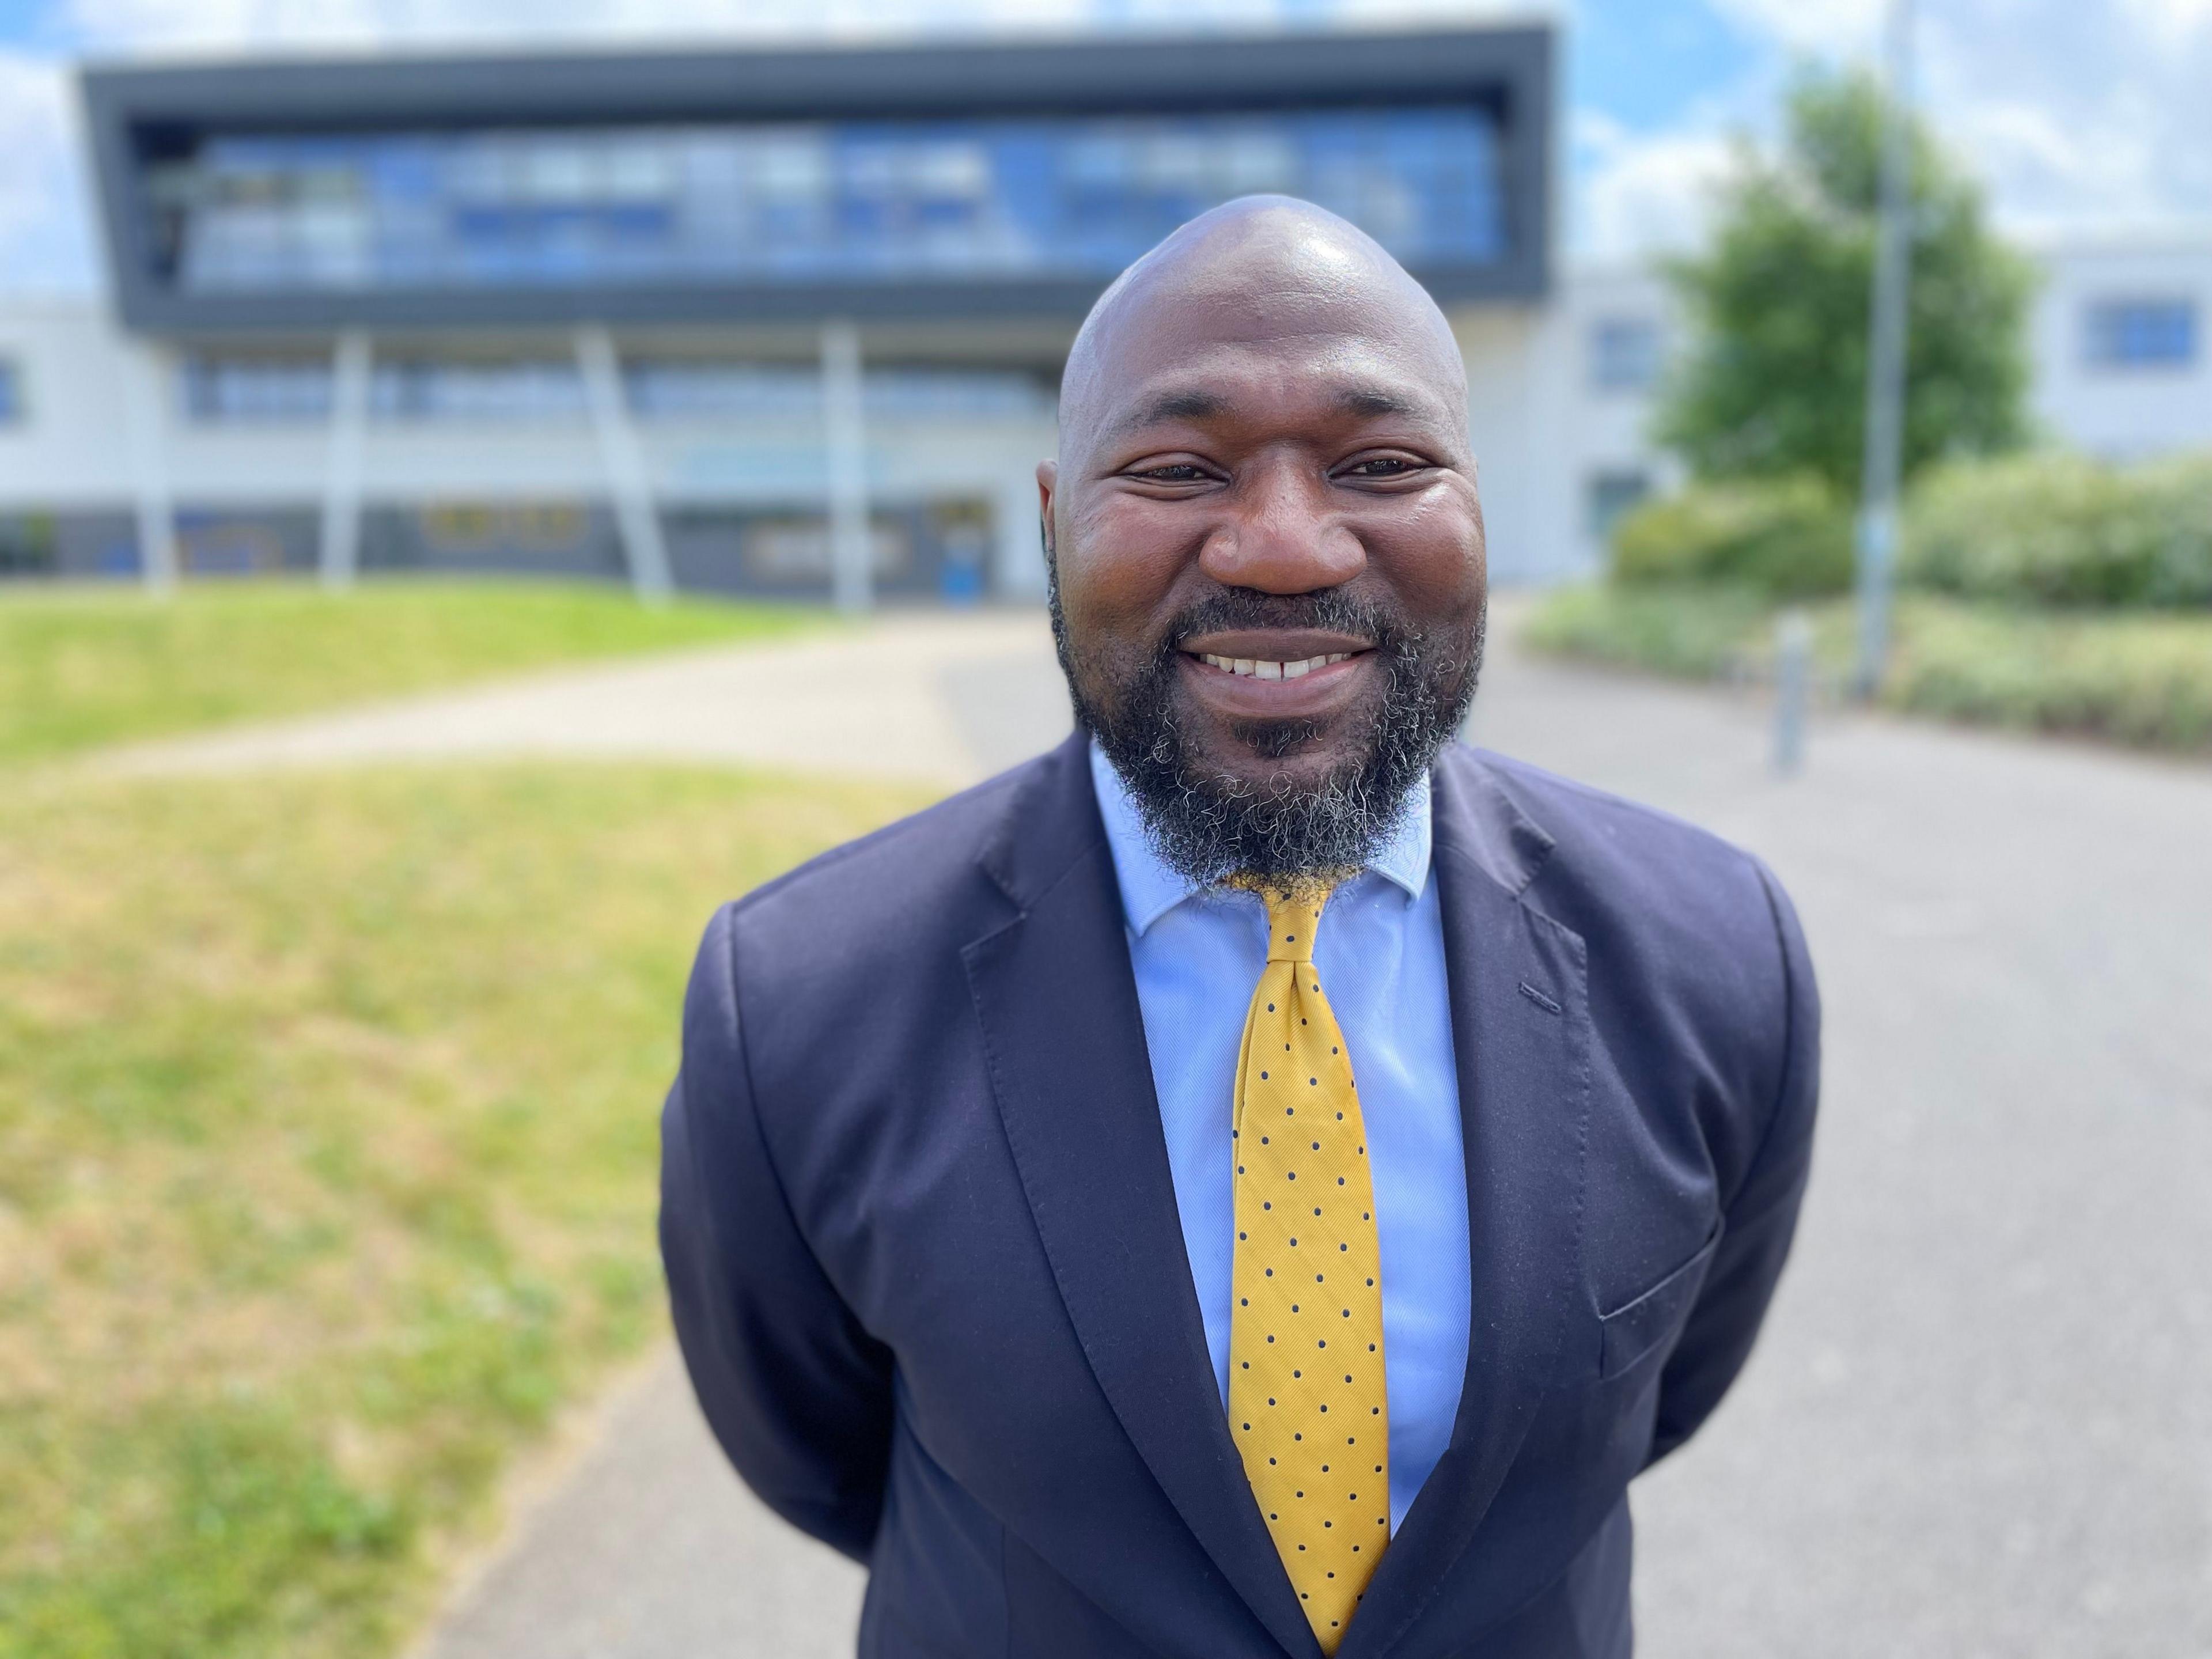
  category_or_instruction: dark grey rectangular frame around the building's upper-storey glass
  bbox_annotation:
[84,24,1555,334]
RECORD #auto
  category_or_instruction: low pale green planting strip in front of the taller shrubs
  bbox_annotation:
[1527,584,2212,752]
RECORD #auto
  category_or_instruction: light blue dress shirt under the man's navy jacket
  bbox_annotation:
[1090,745,1471,1533]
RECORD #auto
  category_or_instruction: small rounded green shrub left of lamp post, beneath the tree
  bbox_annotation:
[1612,478,1851,597]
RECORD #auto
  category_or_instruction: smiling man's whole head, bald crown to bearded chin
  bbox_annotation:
[1037,197,1486,880]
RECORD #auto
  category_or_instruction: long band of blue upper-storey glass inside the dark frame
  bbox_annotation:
[153,106,1506,294]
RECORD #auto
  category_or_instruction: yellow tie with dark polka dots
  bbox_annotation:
[1230,880,1389,1654]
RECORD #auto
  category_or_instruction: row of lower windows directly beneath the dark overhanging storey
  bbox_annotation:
[179,354,1053,422]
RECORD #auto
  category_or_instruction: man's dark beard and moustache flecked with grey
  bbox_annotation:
[1051,571,1486,885]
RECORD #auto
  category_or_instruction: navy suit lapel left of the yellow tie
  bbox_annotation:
[962,739,1319,1659]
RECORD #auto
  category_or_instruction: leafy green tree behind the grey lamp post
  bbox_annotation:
[1657,73,2033,500]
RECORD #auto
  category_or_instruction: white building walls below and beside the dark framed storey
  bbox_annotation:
[13,241,2212,597]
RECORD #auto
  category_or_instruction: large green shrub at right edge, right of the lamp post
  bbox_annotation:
[1900,451,2212,606]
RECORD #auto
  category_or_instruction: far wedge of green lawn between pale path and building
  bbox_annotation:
[0,579,821,766]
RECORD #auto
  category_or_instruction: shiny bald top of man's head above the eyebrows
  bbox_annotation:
[1059,197,1467,467]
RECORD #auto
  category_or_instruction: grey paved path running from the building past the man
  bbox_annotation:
[135,613,2212,1659]
